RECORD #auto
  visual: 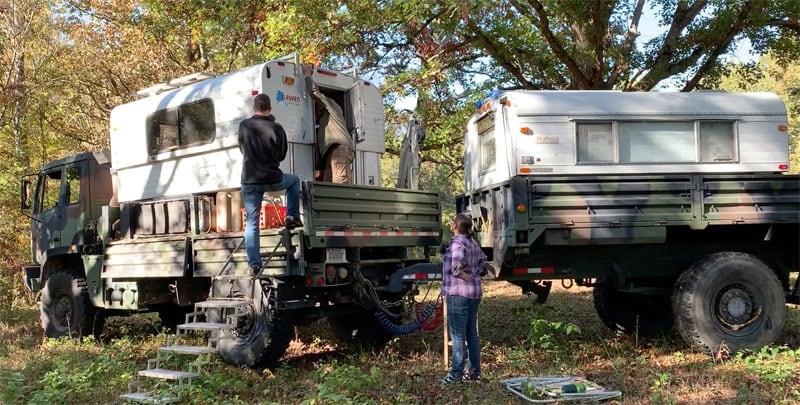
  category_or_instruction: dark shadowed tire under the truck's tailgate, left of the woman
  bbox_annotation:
[328,312,393,350]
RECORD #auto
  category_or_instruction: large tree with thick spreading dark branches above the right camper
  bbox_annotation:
[264,0,800,188]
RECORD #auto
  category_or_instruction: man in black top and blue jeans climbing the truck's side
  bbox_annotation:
[239,94,303,274]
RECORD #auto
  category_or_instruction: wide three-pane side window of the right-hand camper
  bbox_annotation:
[576,120,738,164]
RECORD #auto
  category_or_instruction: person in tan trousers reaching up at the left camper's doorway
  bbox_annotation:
[303,64,355,184]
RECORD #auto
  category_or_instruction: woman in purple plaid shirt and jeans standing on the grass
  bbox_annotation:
[442,213,486,384]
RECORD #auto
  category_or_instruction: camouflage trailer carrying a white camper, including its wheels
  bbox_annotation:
[456,91,800,352]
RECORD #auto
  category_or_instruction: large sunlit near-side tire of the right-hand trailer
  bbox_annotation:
[672,252,786,354]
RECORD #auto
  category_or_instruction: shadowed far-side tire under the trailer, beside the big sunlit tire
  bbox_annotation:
[593,278,673,336]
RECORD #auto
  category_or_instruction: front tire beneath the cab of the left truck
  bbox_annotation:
[40,270,105,338]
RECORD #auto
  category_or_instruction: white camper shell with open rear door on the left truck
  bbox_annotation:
[110,60,385,202]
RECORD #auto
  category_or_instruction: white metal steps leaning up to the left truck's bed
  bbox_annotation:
[120,298,250,404]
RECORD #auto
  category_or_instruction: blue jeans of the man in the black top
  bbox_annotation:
[242,173,300,267]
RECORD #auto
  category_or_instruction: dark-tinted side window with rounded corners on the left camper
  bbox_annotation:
[147,99,216,155]
